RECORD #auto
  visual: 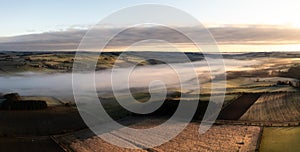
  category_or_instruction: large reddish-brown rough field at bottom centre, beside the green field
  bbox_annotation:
[55,119,261,152]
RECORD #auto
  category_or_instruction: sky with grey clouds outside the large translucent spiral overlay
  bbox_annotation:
[0,0,300,51]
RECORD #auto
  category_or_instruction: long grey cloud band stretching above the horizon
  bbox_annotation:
[0,25,300,51]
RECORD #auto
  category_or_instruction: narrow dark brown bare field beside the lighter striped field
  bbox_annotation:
[218,94,261,120]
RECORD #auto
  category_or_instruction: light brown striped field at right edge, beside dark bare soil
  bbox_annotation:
[240,93,300,122]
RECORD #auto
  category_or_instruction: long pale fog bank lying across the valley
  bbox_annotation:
[0,59,261,100]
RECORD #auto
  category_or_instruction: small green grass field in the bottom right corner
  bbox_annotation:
[260,127,300,152]
